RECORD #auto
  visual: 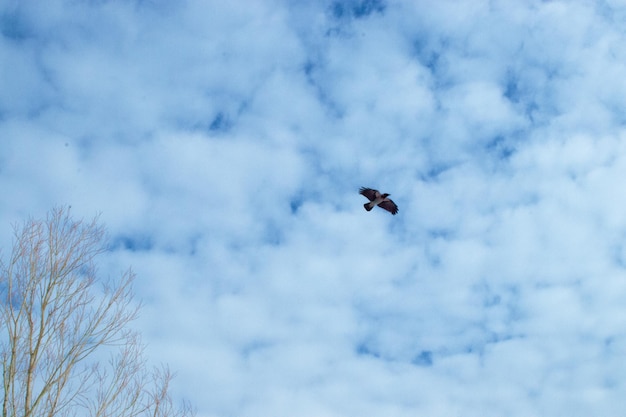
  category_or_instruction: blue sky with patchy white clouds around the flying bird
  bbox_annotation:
[0,0,626,417]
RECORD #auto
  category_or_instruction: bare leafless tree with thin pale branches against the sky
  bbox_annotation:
[0,208,192,417]
